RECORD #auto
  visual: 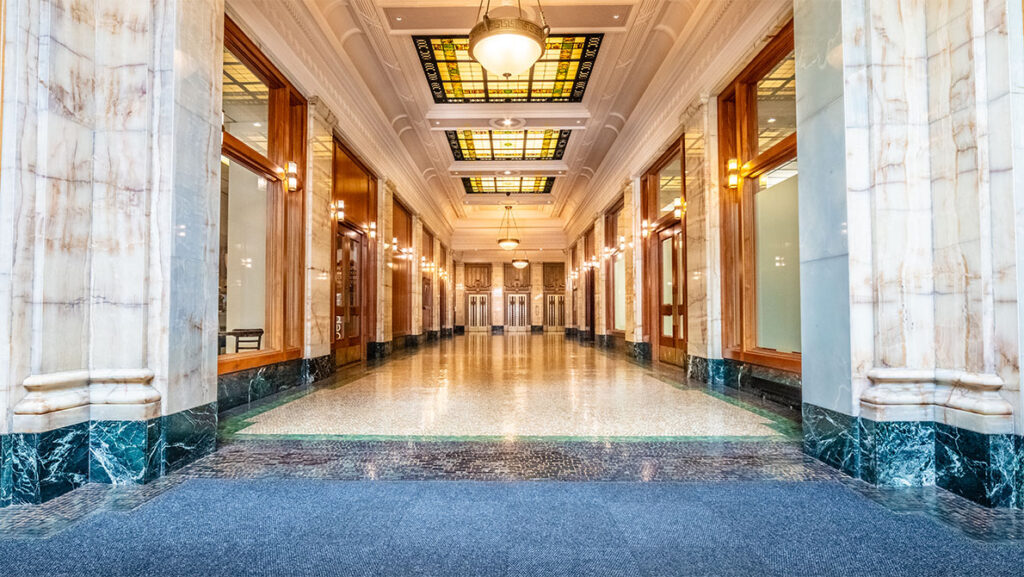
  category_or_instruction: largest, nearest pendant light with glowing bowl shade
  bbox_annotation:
[469,0,551,80]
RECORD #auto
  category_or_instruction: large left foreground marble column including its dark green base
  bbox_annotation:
[0,0,223,504]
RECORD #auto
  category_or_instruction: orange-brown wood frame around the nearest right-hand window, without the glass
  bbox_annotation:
[718,20,802,373]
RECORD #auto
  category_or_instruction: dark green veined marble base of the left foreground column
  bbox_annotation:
[0,403,217,506]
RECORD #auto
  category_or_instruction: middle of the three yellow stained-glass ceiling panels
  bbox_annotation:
[444,128,571,160]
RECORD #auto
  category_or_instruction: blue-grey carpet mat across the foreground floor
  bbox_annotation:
[0,479,1024,577]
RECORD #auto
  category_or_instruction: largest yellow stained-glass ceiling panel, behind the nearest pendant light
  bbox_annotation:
[413,34,604,104]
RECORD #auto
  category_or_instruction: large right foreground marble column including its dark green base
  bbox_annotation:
[796,0,1024,506]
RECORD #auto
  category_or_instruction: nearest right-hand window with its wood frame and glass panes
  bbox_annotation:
[718,23,801,372]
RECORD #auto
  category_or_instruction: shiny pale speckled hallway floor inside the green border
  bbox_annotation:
[230,334,793,440]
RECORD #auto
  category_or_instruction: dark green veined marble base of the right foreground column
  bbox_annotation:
[803,403,1024,508]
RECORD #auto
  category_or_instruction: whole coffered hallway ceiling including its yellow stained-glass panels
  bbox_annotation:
[303,0,698,249]
